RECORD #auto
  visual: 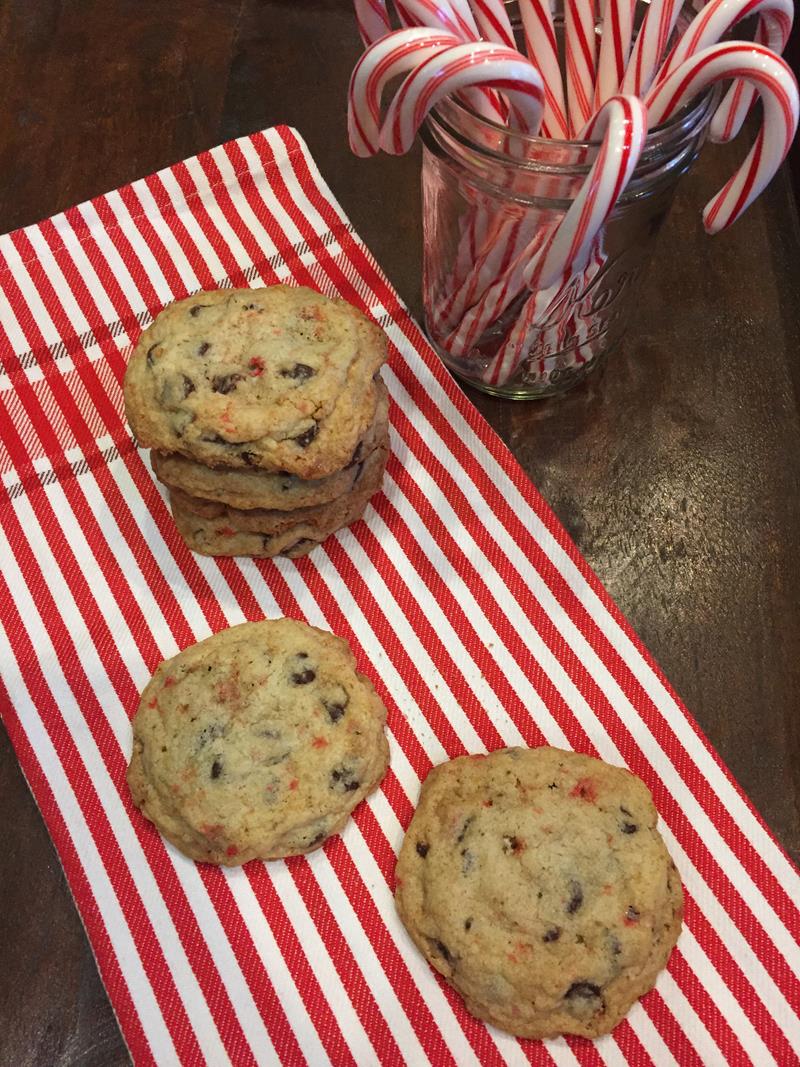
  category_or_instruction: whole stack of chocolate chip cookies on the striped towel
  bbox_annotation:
[125,285,388,557]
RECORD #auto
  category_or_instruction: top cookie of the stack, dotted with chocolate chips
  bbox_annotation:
[125,285,386,478]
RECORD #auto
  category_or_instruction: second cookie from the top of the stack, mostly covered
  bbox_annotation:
[151,379,388,511]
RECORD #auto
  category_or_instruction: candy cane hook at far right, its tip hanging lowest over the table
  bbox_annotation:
[646,43,799,234]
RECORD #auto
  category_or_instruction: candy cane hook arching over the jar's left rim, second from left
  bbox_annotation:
[380,42,544,156]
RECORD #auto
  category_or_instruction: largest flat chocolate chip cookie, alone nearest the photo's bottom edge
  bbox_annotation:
[396,748,683,1038]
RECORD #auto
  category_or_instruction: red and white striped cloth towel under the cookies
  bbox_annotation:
[0,127,800,1067]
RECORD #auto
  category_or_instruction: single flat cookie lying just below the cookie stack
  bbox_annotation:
[128,619,388,865]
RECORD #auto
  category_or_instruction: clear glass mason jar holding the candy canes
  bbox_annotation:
[422,45,718,399]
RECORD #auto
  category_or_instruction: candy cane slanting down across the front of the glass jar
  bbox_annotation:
[484,96,647,385]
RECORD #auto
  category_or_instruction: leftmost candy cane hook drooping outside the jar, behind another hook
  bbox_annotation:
[348,27,461,157]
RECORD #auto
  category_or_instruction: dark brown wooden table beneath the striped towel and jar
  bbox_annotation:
[0,0,800,1067]
